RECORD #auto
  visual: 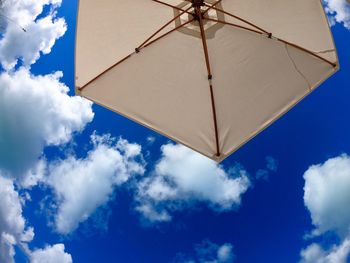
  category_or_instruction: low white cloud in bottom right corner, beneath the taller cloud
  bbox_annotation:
[300,239,350,263]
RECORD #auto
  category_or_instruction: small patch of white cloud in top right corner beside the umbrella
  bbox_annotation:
[324,0,350,29]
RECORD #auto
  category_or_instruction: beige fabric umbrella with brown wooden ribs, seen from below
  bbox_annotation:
[75,0,338,161]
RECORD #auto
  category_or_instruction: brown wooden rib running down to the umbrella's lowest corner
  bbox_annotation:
[195,7,220,157]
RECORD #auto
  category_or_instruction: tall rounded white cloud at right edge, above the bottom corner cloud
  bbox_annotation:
[304,155,350,237]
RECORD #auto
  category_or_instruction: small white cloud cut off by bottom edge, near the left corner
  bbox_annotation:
[30,244,73,263]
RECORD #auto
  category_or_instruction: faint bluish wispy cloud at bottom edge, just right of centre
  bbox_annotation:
[173,240,235,263]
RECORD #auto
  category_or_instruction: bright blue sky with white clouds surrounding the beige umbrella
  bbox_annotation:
[0,0,350,263]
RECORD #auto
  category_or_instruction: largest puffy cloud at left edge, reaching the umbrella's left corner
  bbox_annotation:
[0,68,94,182]
